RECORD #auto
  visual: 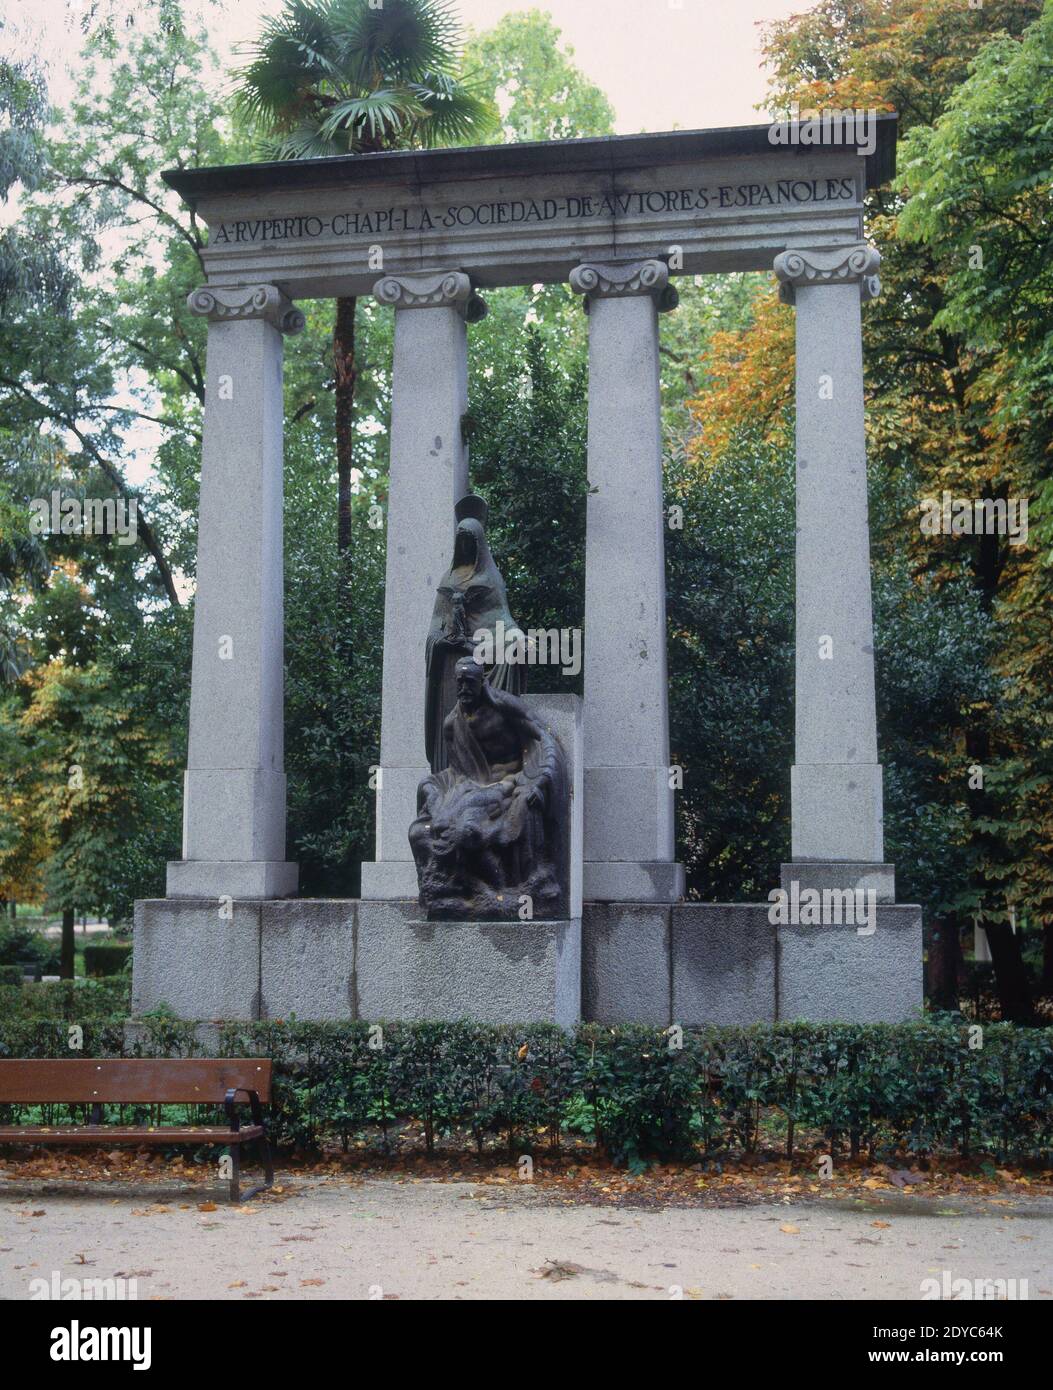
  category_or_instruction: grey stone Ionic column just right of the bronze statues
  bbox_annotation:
[571,261,683,902]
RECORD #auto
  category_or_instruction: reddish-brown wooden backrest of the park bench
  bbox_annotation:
[0,1056,271,1105]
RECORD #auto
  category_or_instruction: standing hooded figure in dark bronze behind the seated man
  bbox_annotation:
[424,492,527,773]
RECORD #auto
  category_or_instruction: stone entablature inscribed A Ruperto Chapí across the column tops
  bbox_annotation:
[165,117,896,297]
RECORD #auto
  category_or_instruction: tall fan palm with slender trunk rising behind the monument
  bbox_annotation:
[238,0,496,552]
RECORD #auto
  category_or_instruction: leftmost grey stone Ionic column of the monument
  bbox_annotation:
[168,285,303,898]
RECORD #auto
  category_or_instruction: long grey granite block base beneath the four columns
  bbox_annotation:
[132,898,922,1027]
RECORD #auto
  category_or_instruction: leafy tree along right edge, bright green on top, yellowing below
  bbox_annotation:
[899,7,1053,1009]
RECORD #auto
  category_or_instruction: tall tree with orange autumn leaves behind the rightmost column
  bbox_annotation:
[692,0,1049,1019]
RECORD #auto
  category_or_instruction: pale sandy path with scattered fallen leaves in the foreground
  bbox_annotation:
[0,1177,1053,1300]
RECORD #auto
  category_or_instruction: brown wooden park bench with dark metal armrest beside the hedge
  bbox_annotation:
[0,1056,274,1202]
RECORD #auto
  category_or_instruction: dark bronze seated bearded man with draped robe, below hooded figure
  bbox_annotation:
[410,656,568,920]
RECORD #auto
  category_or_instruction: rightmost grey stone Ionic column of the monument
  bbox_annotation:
[775,246,884,865]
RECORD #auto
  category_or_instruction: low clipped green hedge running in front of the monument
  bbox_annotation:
[0,1017,1053,1166]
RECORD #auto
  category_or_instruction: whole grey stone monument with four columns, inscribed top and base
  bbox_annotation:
[133,115,922,1024]
